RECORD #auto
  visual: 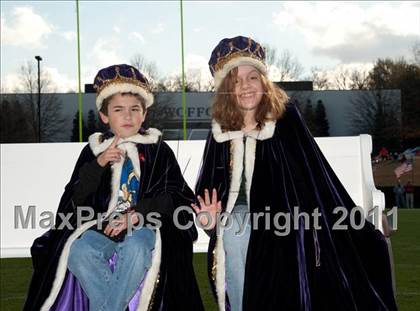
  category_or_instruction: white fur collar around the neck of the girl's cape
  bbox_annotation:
[211,119,276,143]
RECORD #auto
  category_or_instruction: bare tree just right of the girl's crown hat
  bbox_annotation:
[264,44,303,81]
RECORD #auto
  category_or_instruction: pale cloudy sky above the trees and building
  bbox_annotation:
[1,0,420,92]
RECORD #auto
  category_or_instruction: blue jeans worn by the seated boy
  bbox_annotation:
[67,227,156,311]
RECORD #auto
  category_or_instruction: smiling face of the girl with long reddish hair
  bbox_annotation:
[235,65,264,111]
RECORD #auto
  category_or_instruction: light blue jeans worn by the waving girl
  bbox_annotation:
[223,205,251,311]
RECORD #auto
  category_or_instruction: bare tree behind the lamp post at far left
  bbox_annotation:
[16,62,64,141]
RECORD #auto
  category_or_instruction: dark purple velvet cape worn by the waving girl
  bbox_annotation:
[196,104,397,311]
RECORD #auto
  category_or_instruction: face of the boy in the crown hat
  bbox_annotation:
[99,94,146,138]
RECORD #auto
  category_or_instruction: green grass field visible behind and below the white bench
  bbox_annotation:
[0,209,420,311]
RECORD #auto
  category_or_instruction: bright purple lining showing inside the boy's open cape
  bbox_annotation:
[50,254,147,311]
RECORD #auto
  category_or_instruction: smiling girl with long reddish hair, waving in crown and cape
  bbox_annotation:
[192,36,397,311]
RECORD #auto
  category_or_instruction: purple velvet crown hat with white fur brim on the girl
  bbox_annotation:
[209,36,267,90]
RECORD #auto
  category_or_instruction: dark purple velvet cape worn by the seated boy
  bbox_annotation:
[23,140,203,311]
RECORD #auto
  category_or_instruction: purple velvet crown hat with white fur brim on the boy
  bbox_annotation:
[93,64,153,110]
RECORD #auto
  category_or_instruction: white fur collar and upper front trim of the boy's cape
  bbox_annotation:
[89,128,162,217]
